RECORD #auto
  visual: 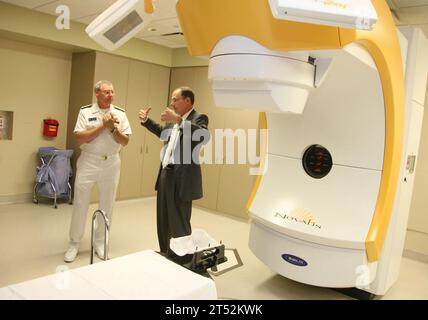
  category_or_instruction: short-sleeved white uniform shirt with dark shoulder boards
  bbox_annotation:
[74,103,132,156]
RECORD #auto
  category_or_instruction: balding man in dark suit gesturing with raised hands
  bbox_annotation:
[138,87,210,257]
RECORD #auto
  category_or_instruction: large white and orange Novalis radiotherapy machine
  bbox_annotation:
[177,0,428,295]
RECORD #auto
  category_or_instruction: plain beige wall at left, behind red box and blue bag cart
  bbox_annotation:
[0,39,71,203]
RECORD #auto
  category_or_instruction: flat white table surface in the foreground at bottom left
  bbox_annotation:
[0,250,217,300]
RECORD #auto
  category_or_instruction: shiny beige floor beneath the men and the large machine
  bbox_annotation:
[0,198,428,300]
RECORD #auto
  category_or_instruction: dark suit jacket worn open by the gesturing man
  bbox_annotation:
[141,109,210,201]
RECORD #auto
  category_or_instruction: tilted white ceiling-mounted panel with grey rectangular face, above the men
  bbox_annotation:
[85,0,153,50]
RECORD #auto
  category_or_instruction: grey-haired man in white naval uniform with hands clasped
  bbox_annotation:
[64,80,131,262]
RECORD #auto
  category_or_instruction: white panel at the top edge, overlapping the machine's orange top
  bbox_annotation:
[269,0,378,30]
